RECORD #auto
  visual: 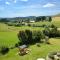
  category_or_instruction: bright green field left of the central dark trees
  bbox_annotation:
[0,32,19,47]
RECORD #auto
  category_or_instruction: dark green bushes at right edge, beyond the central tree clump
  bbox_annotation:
[43,27,60,38]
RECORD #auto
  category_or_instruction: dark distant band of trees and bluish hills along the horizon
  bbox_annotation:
[0,16,52,22]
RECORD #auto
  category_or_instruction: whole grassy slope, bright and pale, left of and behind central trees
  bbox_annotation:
[0,23,43,46]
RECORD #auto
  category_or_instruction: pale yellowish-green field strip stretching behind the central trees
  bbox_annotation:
[0,23,43,32]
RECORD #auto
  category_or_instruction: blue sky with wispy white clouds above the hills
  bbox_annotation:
[0,0,60,17]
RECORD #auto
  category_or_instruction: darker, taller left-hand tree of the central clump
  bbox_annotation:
[18,30,32,44]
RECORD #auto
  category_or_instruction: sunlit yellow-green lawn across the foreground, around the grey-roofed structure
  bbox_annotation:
[0,38,60,60]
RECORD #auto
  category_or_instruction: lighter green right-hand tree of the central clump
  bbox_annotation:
[33,31,45,43]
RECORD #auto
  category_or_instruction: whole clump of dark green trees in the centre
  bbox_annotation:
[18,30,45,44]
